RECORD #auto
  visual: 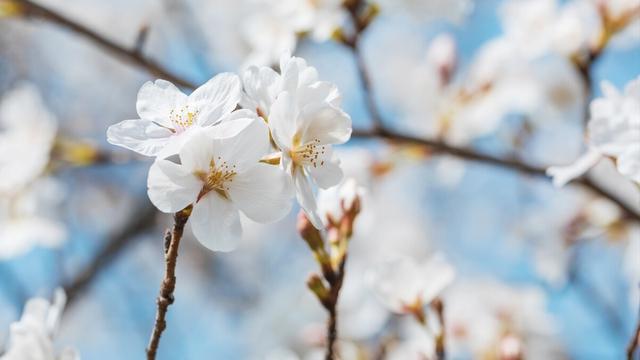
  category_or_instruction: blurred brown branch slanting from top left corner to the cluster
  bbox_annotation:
[14,0,196,89]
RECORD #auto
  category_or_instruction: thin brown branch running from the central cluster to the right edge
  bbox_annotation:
[352,129,640,222]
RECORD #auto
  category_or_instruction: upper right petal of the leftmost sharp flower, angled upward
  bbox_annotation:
[189,73,242,126]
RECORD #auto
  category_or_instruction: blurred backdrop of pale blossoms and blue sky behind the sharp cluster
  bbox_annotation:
[0,0,640,360]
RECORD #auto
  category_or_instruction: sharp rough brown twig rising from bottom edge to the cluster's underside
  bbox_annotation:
[147,205,192,360]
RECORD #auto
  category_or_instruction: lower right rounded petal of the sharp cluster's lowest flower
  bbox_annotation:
[229,163,293,223]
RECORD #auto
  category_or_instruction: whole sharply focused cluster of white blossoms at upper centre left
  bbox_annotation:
[107,55,351,251]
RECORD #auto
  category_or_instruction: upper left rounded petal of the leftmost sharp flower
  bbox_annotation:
[136,80,187,126]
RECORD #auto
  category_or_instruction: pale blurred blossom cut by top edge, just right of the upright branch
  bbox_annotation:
[377,0,473,23]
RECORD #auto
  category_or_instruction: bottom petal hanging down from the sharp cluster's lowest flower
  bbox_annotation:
[189,191,242,251]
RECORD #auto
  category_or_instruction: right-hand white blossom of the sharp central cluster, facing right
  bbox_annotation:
[243,55,351,228]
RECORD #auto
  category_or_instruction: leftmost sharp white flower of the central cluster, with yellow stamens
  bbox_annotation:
[107,73,242,156]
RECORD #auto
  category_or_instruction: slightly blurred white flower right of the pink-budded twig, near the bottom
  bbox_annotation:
[368,254,455,314]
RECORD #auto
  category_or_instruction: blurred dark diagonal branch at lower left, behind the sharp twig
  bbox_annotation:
[64,206,156,306]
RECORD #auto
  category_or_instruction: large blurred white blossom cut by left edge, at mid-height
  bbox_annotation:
[0,84,57,194]
